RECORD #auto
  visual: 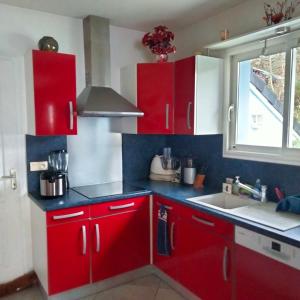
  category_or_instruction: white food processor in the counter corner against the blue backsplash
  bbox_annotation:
[149,148,181,182]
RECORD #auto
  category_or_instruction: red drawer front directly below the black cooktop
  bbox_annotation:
[91,196,149,218]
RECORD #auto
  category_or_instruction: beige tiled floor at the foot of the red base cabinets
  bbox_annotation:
[1,275,185,300]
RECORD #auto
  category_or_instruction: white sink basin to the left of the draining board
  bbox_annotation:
[187,193,259,210]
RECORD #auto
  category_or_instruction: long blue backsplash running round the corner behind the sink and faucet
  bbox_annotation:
[123,134,300,200]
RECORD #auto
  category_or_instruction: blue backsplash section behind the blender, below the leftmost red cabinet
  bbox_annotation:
[26,135,67,192]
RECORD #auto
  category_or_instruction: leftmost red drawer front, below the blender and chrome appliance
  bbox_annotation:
[47,206,90,226]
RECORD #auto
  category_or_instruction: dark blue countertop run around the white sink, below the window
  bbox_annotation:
[130,180,300,248]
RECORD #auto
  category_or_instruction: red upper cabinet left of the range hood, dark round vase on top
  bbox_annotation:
[26,50,77,135]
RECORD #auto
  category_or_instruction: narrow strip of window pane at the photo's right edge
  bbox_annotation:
[289,48,300,148]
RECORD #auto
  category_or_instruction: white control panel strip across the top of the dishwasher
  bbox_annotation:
[235,226,300,270]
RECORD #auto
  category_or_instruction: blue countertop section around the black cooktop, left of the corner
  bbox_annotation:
[28,184,151,211]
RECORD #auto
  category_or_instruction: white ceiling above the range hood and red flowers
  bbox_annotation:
[0,0,247,31]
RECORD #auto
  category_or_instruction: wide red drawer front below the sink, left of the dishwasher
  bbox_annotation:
[182,207,234,240]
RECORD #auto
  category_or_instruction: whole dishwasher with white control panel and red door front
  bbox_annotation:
[235,226,300,300]
